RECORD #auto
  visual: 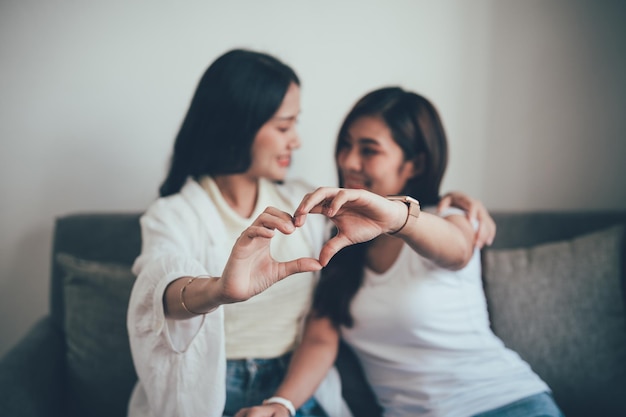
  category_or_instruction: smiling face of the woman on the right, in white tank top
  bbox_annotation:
[337,116,416,196]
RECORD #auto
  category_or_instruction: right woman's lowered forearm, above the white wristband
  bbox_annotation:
[275,319,339,409]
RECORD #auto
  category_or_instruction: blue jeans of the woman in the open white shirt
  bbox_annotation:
[224,354,327,417]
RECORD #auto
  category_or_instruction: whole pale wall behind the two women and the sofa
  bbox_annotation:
[0,0,626,354]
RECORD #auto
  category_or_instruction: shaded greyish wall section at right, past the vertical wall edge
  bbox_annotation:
[481,0,626,210]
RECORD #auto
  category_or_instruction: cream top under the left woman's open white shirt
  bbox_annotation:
[199,177,317,359]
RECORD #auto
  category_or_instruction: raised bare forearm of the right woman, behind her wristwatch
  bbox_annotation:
[394,212,474,269]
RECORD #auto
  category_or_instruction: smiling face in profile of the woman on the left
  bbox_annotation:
[246,83,300,181]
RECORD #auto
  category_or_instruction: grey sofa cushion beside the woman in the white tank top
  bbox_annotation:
[483,225,626,416]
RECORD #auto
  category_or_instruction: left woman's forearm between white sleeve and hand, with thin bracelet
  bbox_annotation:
[163,277,224,319]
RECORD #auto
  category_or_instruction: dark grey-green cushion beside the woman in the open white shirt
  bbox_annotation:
[56,254,137,416]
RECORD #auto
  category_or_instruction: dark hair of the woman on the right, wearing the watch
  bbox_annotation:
[313,87,448,327]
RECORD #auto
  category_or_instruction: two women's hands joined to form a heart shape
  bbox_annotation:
[221,187,406,303]
